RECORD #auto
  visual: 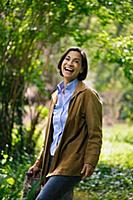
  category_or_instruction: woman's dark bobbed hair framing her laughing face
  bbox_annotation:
[58,47,88,81]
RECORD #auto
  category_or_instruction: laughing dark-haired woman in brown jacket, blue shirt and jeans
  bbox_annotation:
[29,48,102,200]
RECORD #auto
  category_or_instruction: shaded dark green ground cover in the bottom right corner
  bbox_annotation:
[77,164,133,200]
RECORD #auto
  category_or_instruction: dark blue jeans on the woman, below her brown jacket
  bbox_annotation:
[36,175,80,200]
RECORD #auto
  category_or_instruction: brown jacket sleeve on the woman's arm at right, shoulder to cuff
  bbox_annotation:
[84,90,102,167]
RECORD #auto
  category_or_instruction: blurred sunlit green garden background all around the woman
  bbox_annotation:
[0,0,133,200]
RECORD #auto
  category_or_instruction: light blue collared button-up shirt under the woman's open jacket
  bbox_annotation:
[50,79,78,156]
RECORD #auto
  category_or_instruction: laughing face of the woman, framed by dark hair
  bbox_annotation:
[61,51,83,83]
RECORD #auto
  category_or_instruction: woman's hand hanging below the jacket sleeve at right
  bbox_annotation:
[81,164,94,179]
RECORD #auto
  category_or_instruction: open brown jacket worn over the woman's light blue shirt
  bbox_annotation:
[35,81,102,181]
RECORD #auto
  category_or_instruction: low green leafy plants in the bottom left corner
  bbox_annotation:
[0,153,33,200]
